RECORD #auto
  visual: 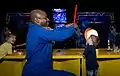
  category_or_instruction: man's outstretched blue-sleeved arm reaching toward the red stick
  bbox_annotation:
[37,26,75,41]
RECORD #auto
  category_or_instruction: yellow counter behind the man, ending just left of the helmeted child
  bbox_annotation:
[0,49,82,76]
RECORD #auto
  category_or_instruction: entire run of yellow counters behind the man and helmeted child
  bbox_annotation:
[0,48,120,76]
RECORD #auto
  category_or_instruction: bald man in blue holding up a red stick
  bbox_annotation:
[22,10,75,76]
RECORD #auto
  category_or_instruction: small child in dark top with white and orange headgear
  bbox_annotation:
[83,29,99,76]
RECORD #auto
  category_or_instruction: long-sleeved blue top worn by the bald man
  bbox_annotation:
[23,24,75,76]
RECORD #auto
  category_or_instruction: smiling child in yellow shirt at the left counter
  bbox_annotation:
[0,34,16,59]
